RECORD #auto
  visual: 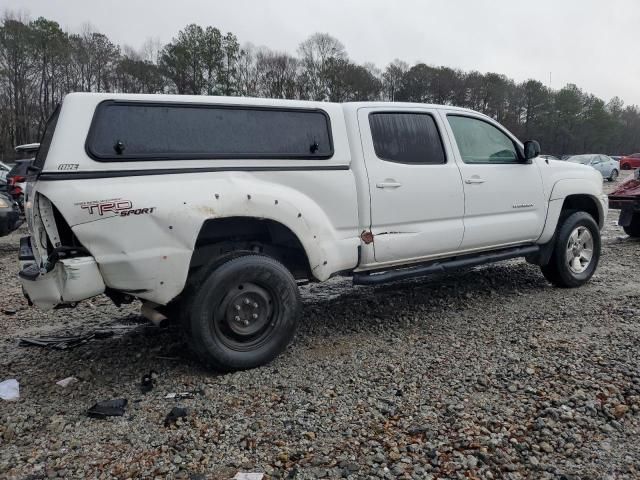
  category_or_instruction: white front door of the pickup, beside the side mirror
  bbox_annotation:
[441,112,547,250]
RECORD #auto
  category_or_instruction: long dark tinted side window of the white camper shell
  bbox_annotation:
[87,101,333,161]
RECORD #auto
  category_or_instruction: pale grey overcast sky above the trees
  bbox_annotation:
[5,0,640,105]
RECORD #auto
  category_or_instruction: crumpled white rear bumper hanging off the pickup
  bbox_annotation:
[18,237,105,310]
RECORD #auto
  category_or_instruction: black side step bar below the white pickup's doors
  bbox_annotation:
[353,245,540,285]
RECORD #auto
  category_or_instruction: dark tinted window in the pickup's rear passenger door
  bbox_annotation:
[369,113,446,164]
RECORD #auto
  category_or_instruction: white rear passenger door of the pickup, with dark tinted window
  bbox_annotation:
[358,107,464,263]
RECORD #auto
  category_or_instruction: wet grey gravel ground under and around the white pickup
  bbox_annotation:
[0,174,640,479]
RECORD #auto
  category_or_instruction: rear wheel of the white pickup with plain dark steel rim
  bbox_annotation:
[183,254,301,372]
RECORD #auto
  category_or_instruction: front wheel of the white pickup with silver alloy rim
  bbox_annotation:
[541,212,601,288]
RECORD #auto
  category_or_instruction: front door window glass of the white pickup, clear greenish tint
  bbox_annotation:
[448,115,519,163]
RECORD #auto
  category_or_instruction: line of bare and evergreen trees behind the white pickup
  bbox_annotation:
[0,13,640,159]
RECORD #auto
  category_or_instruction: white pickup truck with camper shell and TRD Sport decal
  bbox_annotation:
[20,93,607,370]
